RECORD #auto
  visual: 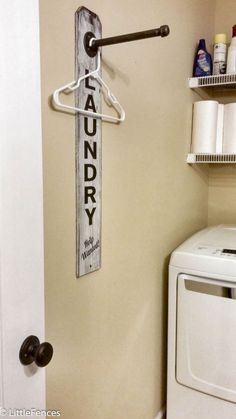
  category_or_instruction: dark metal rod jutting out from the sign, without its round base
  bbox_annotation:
[91,25,170,49]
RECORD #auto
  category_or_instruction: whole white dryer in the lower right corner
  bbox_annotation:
[167,225,236,419]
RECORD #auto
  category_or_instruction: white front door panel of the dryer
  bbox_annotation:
[176,274,236,402]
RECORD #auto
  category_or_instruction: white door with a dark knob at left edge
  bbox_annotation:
[0,0,45,417]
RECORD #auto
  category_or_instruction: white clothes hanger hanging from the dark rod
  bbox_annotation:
[52,47,125,122]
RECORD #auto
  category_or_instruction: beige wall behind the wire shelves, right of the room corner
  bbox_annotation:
[208,0,236,225]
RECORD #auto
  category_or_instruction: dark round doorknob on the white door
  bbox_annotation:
[19,335,53,367]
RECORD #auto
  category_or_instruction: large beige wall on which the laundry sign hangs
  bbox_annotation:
[40,0,215,419]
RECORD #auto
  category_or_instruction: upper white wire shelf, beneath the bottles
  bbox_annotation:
[188,74,236,89]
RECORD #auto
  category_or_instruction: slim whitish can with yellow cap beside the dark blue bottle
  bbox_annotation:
[213,33,227,75]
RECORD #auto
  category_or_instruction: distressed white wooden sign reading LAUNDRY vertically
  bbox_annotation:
[75,7,102,277]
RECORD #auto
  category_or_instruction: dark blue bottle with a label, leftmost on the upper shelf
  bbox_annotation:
[193,39,212,77]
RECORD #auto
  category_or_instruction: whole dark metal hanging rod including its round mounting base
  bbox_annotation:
[84,25,170,57]
